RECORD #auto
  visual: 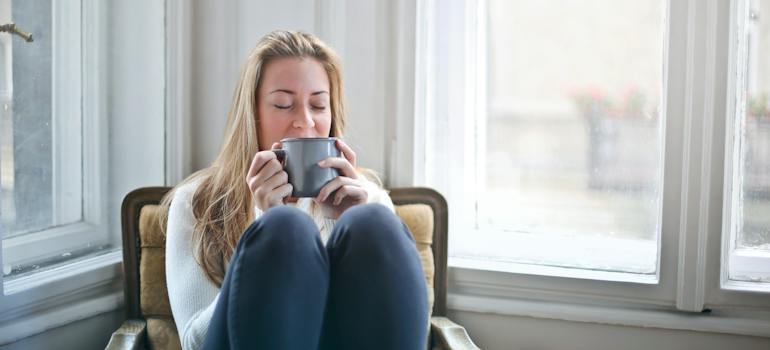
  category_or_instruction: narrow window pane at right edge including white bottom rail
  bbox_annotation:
[730,1,770,282]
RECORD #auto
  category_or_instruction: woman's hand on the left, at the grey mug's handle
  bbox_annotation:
[246,142,293,212]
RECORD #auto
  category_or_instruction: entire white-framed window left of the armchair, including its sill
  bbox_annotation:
[0,0,166,345]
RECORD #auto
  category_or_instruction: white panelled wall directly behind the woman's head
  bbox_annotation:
[190,0,388,173]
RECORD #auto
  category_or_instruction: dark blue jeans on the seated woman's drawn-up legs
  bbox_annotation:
[203,204,428,350]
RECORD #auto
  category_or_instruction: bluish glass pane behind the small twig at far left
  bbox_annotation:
[0,0,82,239]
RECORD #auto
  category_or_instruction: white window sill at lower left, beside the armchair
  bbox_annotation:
[0,250,123,345]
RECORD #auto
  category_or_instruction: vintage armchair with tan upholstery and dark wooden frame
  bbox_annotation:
[106,187,478,350]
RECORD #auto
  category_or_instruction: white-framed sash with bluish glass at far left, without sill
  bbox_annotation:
[0,0,104,282]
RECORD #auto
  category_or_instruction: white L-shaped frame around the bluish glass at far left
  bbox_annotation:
[2,1,114,278]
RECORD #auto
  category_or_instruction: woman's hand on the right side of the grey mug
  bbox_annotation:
[313,140,369,219]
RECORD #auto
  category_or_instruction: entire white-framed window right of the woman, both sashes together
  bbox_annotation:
[414,0,770,320]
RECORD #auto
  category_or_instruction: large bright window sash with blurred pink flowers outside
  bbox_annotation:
[426,0,666,283]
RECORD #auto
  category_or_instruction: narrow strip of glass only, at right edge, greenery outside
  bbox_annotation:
[736,1,770,252]
